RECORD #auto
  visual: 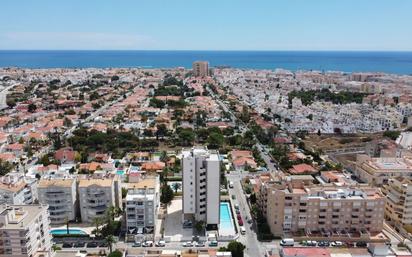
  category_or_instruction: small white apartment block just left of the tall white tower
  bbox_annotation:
[126,177,159,233]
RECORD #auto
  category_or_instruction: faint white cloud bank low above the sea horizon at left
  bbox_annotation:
[0,32,156,50]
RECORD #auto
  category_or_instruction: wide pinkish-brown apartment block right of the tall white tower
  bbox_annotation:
[260,177,385,235]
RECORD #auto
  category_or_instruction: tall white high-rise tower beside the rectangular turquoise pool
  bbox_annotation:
[182,147,220,227]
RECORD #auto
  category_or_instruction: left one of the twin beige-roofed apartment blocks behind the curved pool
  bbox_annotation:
[38,178,77,224]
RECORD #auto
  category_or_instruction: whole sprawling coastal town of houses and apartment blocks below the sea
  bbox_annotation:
[0,61,412,257]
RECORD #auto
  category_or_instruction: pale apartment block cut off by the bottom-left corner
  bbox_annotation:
[0,205,53,257]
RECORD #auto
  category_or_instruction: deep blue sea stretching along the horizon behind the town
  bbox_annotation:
[0,50,412,75]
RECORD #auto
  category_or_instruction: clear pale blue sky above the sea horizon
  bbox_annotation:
[0,0,412,51]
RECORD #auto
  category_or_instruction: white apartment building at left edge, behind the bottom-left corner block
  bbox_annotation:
[0,172,37,204]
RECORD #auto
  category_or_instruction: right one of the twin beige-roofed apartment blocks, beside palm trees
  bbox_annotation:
[78,177,122,223]
